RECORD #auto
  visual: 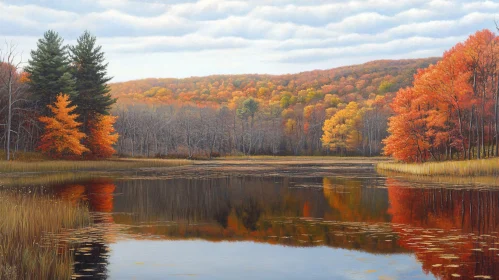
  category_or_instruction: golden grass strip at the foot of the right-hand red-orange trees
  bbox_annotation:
[376,158,499,176]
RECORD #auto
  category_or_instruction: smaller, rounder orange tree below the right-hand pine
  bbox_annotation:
[87,115,119,158]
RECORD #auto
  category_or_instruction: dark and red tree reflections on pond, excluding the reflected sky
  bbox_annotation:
[41,176,499,279]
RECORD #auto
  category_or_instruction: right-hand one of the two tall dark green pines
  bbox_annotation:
[69,31,116,132]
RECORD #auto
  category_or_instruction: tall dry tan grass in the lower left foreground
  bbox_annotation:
[0,192,91,280]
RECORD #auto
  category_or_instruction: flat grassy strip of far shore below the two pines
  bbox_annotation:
[0,159,191,173]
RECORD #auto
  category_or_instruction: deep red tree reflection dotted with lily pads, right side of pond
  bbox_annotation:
[386,178,499,279]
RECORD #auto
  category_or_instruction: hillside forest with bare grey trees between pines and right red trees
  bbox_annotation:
[110,58,438,158]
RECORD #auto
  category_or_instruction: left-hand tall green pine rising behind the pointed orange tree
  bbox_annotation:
[25,30,76,114]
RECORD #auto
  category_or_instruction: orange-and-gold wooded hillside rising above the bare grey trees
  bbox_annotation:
[111,58,439,108]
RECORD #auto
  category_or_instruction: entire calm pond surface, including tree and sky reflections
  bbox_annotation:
[11,165,499,279]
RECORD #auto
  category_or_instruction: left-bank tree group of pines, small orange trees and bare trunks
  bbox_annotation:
[0,30,118,160]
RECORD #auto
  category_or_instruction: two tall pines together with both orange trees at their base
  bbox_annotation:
[26,31,118,159]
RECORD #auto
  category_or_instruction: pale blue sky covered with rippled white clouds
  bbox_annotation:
[0,0,499,82]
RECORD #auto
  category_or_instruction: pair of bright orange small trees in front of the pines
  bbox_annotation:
[39,94,118,158]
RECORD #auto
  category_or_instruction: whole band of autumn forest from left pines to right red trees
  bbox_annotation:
[0,30,499,162]
